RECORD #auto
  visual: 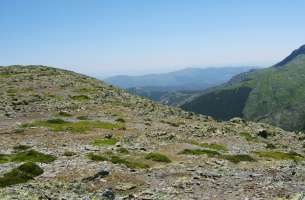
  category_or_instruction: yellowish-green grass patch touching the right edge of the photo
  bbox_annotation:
[254,151,304,161]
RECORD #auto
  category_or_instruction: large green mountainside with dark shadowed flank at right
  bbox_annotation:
[182,45,305,130]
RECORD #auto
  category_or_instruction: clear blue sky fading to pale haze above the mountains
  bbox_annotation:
[0,0,305,77]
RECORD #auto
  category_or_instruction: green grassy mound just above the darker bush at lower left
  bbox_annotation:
[10,150,56,163]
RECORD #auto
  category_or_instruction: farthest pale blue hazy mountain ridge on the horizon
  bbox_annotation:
[104,67,253,91]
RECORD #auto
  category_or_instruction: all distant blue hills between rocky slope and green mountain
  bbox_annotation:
[104,67,254,106]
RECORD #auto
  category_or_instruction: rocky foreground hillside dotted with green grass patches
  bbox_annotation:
[0,66,305,200]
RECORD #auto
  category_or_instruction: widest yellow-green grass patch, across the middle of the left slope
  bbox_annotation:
[22,119,124,133]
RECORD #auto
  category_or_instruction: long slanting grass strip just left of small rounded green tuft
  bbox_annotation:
[88,153,149,169]
